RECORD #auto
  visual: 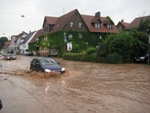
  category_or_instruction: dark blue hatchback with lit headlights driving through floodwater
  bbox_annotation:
[30,58,65,74]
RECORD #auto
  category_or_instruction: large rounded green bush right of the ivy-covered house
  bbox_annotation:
[98,30,148,61]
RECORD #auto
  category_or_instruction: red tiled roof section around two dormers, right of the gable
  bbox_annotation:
[81,15,119,33]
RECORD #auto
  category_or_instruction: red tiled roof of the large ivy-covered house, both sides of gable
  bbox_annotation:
[43,9,119,33]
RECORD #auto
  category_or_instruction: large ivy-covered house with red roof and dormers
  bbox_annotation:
[31,9,119,55]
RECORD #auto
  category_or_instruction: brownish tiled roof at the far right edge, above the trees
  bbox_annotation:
[127,16,150,29]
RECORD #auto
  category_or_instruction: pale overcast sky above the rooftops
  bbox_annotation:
[0,0,150,37]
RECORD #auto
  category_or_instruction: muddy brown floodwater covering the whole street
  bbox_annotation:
[0,56,150,113]
